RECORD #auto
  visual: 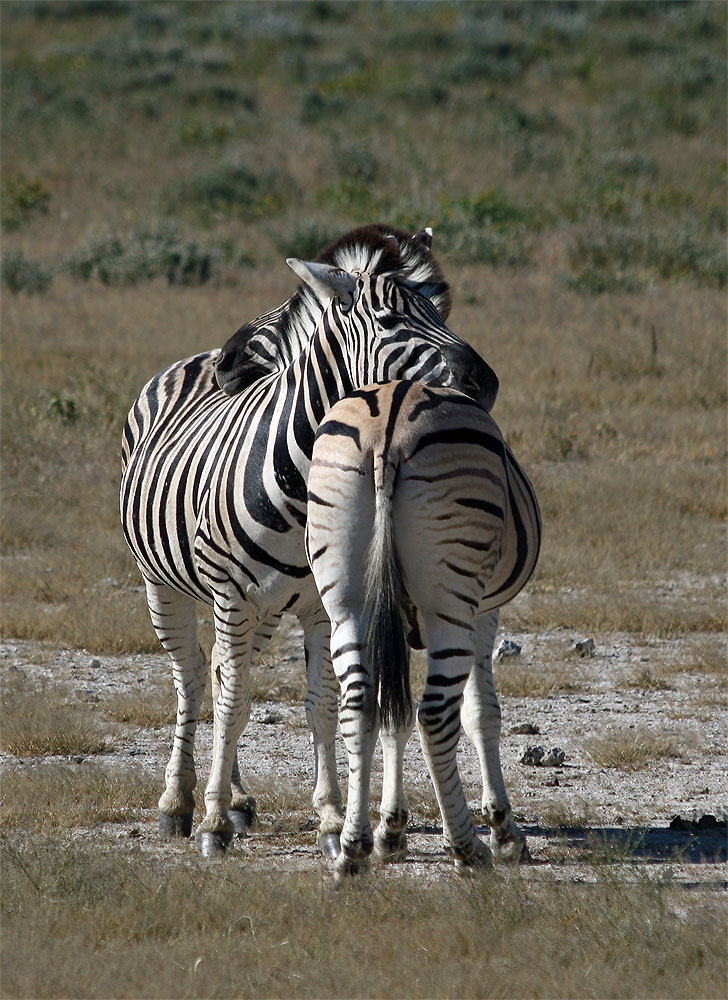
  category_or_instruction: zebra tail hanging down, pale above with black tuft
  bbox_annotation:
[365,461,412,728]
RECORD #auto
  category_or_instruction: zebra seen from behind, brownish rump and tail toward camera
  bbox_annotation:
[306,381,541,874]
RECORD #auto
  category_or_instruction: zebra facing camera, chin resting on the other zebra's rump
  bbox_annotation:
[121,227,497,853]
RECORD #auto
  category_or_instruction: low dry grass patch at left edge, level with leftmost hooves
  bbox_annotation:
[0,761,159,835]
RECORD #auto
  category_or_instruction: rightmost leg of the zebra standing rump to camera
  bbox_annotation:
[462,611,529,862]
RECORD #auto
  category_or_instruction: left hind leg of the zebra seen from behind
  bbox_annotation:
[331,618,379,878]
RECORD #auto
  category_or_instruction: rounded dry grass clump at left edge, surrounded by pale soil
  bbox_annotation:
[0,675,110,757]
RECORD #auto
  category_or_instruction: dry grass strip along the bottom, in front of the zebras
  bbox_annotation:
[2,838,725,998]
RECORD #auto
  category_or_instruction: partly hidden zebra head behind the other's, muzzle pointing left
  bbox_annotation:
[215,224,450,395]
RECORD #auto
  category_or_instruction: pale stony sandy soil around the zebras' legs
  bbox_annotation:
[0,625,728,888]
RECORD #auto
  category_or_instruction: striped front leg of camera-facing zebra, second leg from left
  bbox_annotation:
[196,603,255,856]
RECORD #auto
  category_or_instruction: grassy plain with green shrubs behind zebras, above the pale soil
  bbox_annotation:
[0,0,726,649]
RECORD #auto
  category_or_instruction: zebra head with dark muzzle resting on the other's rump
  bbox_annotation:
[287,258,498,411]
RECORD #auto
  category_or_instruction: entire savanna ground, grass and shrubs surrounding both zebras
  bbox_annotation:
[0,0,728,998]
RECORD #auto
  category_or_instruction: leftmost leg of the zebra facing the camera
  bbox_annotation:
[145,579,205,837]
